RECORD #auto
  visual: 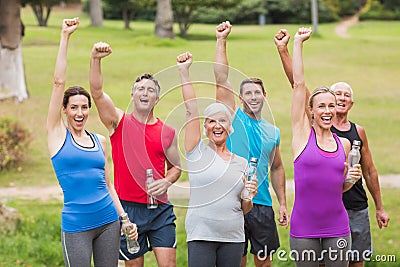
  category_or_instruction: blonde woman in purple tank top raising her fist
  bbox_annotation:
[290,28,361,267]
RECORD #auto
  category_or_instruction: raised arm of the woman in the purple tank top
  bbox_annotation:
[292,28,312,159]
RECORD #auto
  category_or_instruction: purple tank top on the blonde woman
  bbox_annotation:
[290,128,350,238]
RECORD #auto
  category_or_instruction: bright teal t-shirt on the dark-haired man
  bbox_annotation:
[226,108,280,206]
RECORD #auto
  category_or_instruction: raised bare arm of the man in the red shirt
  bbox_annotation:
[90,42,124,135]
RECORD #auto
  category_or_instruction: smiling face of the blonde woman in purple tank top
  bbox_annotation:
[310,92,336,129]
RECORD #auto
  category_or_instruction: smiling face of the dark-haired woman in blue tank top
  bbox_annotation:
[63,95,89,132]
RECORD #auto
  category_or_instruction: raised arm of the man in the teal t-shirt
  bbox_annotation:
[214,21,236,112]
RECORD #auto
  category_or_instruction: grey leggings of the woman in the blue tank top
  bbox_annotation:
[61,221,120,267]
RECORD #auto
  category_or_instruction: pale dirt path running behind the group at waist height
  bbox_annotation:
[0,174,400,201]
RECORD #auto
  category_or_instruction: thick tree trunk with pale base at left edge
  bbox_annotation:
[0,0,28,101]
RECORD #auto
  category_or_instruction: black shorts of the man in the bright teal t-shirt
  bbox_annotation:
[243,204,280,257]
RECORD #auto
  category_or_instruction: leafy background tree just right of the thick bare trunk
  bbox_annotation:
[172,0,241,37]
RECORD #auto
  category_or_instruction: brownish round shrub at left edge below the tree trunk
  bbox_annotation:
[0,118,31,171]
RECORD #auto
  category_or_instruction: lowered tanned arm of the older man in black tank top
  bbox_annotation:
[357,125,390,228]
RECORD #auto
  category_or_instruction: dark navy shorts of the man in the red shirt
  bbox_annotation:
[119,200,176,260]
